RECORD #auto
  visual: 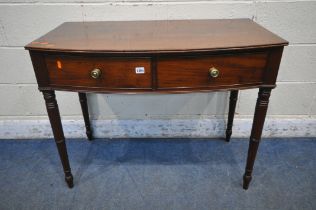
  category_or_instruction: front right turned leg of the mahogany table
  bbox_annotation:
[243,88,271,190]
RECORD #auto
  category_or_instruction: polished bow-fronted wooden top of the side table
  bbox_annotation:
[25,19,288,53]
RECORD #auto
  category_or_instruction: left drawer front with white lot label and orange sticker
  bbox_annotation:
[46,56,151,89]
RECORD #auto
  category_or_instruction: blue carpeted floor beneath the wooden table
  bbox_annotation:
[0,138,316,210]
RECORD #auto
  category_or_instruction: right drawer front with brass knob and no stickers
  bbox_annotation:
[157,53,267,89]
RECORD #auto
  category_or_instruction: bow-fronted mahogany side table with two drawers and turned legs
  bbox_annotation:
[25,19,288,189]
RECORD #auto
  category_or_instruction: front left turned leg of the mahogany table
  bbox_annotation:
[42,90,73,188]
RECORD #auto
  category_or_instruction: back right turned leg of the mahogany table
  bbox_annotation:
[226,90,238,142]
